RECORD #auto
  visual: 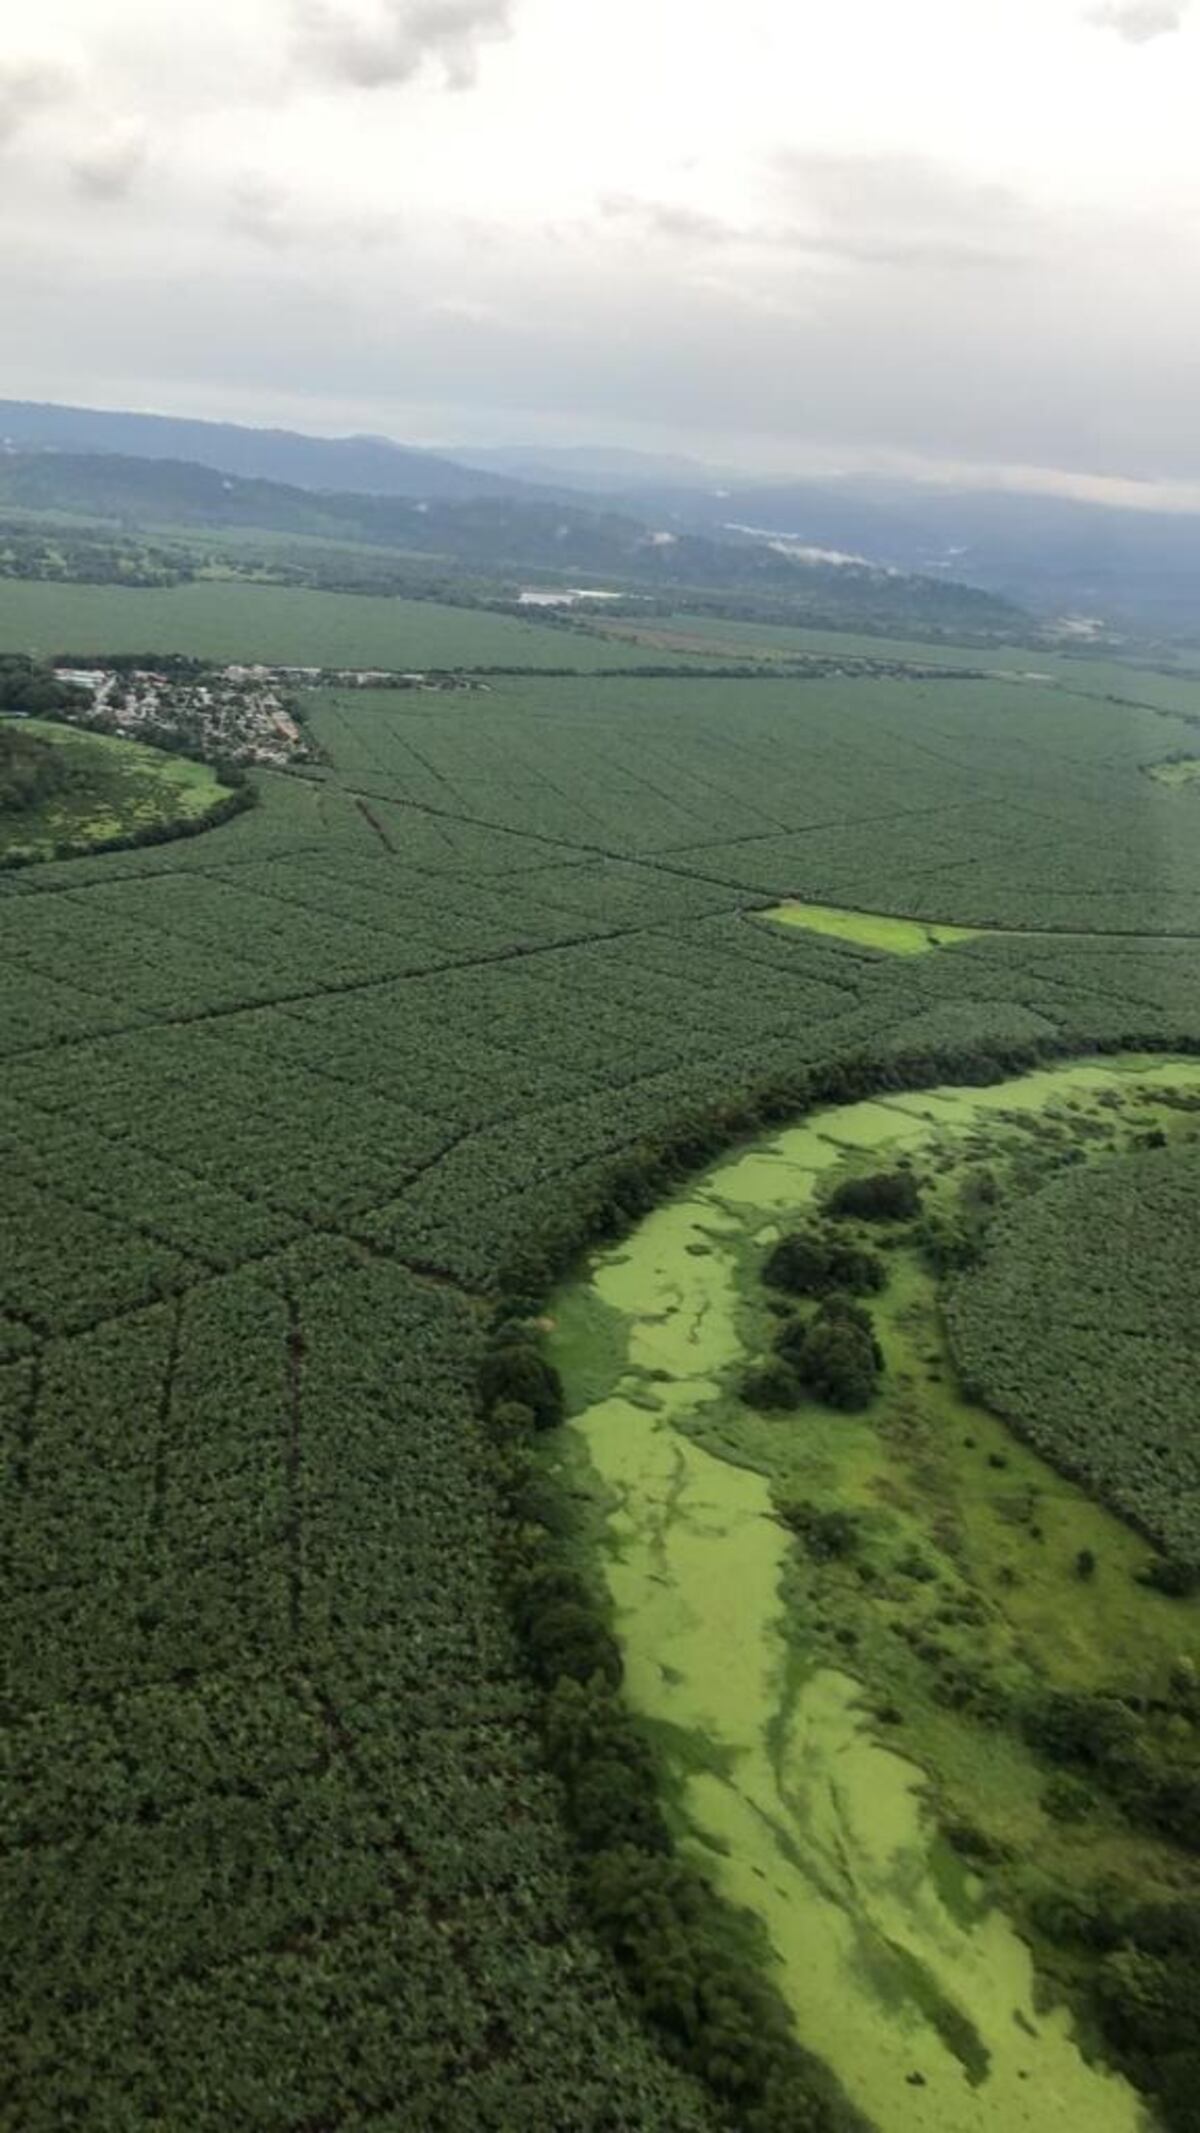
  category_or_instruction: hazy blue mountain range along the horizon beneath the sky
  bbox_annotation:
[0,401,1200,638]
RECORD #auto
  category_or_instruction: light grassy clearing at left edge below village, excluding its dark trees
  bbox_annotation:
[0,719,228,864]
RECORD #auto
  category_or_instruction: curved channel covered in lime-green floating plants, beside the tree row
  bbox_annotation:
[552,1058,1200,2133]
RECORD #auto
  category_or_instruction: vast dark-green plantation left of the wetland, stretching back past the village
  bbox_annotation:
[0,635,1200,2133]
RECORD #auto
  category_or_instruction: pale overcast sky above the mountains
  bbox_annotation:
[0,0,1200,499]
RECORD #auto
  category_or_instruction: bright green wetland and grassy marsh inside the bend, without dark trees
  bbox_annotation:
[550,1058,1200,2133]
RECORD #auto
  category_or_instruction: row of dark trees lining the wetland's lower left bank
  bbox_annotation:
[480,1303,865,2133]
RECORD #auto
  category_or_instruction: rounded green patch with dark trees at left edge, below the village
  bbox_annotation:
[0,719,244,868]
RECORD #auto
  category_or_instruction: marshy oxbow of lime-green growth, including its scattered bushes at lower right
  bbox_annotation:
[552,1062,1200,2133]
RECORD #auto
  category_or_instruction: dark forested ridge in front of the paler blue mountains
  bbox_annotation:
[0,450,1025,638]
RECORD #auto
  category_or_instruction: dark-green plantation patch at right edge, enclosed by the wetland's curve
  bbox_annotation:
[948,1148,1200,1591]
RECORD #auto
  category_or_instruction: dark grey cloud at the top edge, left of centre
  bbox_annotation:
[292,0,514,90]
